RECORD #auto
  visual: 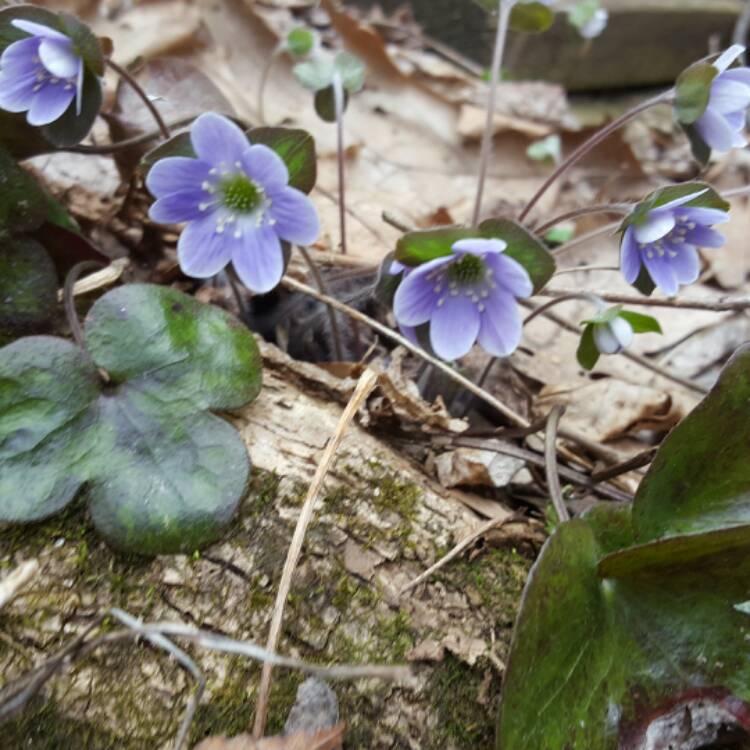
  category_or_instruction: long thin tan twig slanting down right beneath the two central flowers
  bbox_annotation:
[281,276,620,469]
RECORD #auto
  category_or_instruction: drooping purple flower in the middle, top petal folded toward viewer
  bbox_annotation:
[393,239,533,360]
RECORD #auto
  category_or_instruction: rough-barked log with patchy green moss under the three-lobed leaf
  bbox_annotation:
[0,347,529,750]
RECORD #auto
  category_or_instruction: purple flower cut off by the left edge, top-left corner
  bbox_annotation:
[0,19,84,125]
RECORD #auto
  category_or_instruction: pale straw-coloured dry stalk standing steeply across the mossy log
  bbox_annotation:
[253,369,378,738]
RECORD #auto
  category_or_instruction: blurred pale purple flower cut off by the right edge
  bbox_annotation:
[695,44,750,152]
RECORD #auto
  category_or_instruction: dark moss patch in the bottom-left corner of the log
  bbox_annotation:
[2,700,148,750]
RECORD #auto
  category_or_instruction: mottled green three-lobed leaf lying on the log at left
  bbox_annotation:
[0,284,261,554]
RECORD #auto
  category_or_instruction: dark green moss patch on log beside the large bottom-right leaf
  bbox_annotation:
[425,656,500,748]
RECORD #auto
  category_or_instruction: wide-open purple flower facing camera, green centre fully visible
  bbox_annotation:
[146,112,320,294]
